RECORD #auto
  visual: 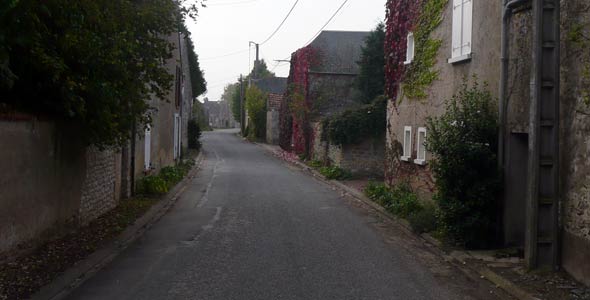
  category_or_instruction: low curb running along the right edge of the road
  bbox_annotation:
[256,143,540,300]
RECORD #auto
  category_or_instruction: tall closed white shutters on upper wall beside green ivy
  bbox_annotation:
[449,0,474,63]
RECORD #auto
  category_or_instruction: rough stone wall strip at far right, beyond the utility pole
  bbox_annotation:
[560,0,590,285]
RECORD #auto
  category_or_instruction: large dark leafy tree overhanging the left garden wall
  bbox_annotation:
[0,0,206,147]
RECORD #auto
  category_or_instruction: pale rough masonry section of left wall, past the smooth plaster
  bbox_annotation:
[79,147,120,224]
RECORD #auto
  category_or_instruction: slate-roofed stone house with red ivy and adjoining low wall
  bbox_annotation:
[280,31,385,174]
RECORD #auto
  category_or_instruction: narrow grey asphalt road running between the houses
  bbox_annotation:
[69,131,508,300]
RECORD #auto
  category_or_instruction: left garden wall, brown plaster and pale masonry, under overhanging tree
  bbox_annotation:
[0,114,121,253]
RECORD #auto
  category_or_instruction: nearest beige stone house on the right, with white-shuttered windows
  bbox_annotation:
[386,0,590,284]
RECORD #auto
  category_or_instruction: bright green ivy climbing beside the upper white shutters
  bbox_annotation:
[402,0,448,99]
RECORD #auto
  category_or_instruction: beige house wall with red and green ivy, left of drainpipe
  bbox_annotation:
[385,0,501,198]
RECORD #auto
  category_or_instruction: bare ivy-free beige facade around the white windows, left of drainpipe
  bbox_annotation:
[385,1,502,198]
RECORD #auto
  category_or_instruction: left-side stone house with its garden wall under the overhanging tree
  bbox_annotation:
[0,33,192,257]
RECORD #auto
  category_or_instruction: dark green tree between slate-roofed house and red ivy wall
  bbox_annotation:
[356,23,385,103]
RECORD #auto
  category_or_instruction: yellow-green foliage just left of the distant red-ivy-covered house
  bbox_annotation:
[246,86,268,139]
